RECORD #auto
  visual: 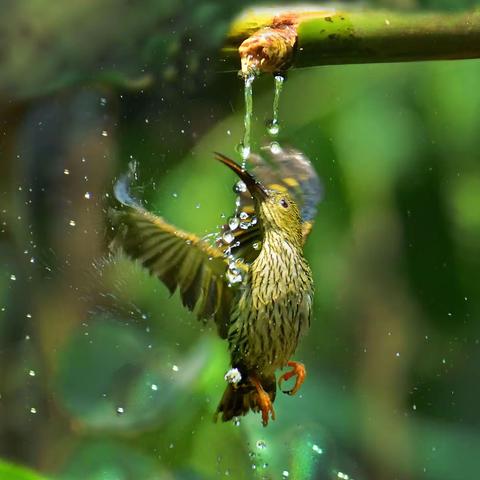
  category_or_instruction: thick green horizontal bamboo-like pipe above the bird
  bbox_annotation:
[220,7,480,70]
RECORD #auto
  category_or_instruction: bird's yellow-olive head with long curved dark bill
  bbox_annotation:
[215,153,302,245]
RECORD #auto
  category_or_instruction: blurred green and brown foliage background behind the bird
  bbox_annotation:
[0,0,480,480]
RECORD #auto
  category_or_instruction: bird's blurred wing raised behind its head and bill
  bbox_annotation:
[217,148,323,263]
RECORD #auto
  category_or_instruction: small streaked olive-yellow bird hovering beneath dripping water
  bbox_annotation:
[113,149,321,426]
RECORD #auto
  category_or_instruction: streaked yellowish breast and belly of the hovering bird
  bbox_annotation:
[229,238,313,370]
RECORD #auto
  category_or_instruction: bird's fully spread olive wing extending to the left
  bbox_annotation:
[111,174,244,338]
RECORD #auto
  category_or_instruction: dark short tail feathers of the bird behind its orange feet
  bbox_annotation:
[214,376,277,422]
